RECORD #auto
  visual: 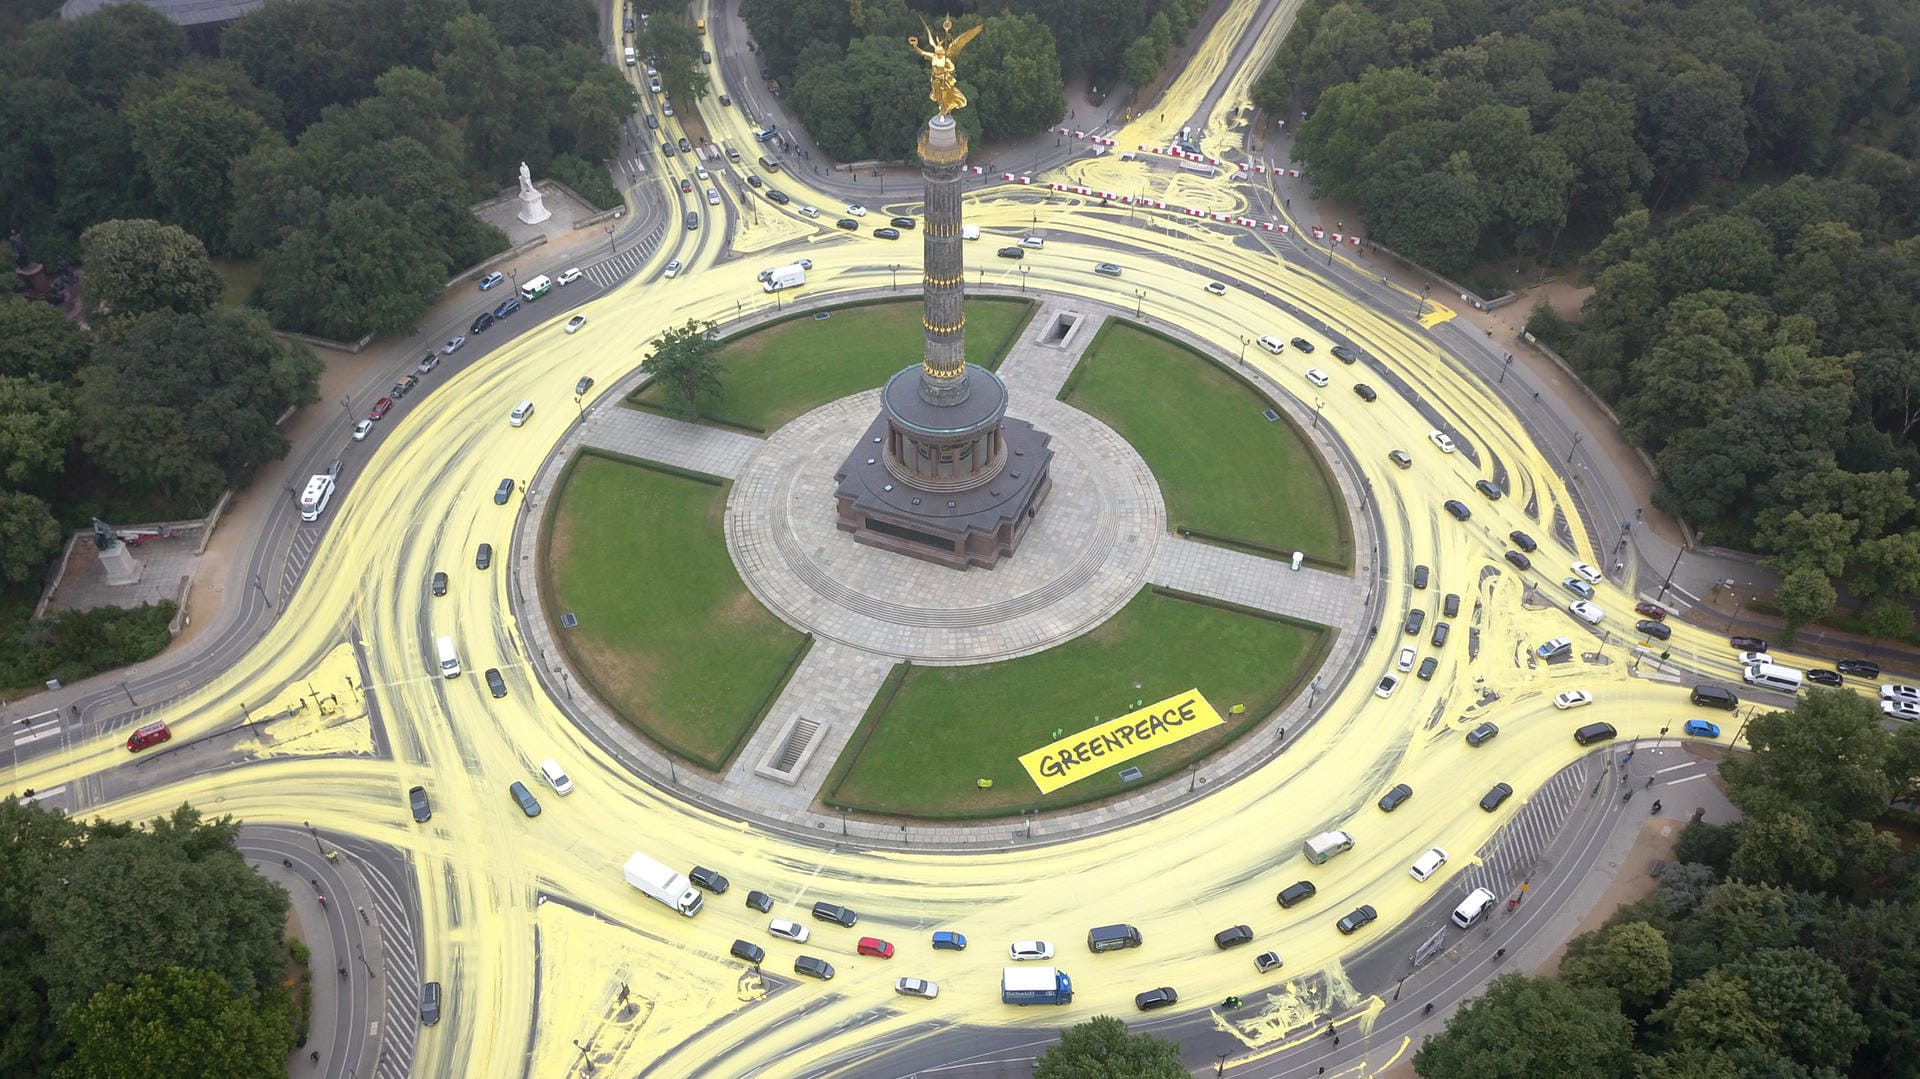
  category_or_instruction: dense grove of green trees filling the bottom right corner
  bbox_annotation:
[1413,689,1920,1079]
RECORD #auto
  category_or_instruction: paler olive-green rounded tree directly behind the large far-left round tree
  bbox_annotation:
[81,221,227,319]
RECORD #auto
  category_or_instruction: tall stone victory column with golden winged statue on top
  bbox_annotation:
[833,17,1054,570]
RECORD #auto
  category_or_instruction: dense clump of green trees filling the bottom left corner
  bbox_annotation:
[0,797,298,1079]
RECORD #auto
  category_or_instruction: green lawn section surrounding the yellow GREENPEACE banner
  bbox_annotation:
[828,589,1327,818]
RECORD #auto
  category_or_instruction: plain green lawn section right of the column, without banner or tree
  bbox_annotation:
[1066,323,1354,568]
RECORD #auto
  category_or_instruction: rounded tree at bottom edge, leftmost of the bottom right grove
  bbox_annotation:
[1413,973,1632,1079]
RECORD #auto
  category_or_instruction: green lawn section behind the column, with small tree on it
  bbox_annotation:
[636,300,1029,430]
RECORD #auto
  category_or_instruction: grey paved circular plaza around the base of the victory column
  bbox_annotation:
[726,390,1167,664]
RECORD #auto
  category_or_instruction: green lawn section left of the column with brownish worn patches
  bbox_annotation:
[543,455,804,768]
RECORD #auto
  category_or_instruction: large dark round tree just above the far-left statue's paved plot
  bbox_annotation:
[75,307,321,503]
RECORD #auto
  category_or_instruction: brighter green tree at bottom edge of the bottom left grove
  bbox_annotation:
[60,966,294,1079]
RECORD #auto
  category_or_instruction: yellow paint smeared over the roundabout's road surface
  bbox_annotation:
[19,4,1791,1077]
